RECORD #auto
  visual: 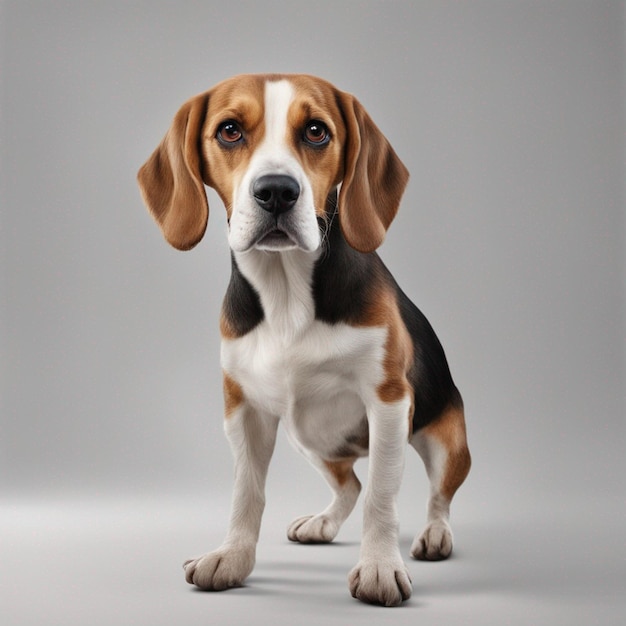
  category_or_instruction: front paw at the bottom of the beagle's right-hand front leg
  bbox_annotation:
[348,559,412,606]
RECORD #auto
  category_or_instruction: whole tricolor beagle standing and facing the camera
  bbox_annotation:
[138,74,470,606]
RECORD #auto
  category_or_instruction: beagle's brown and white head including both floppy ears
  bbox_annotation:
[138,75,408,252]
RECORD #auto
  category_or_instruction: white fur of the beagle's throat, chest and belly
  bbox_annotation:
[222,246,387,456]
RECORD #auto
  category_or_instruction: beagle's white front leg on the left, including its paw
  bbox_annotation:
[184,402,278,591]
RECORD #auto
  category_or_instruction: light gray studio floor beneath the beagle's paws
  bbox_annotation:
[0,496,626,626]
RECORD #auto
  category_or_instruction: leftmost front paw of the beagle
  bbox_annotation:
[183,546,255,591]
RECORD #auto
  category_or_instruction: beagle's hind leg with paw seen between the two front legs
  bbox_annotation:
[287,455,361,543]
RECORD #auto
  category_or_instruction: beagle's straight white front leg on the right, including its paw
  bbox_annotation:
[348,398,412,606]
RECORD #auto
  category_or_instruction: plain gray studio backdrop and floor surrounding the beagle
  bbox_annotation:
[0,0,626,625]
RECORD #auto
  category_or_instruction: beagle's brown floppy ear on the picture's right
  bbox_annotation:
[339,93,409,252]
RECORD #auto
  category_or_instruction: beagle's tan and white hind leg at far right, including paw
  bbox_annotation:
[411,405,471,561]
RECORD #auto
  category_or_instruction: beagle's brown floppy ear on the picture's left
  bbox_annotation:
[137,93,209,250]
